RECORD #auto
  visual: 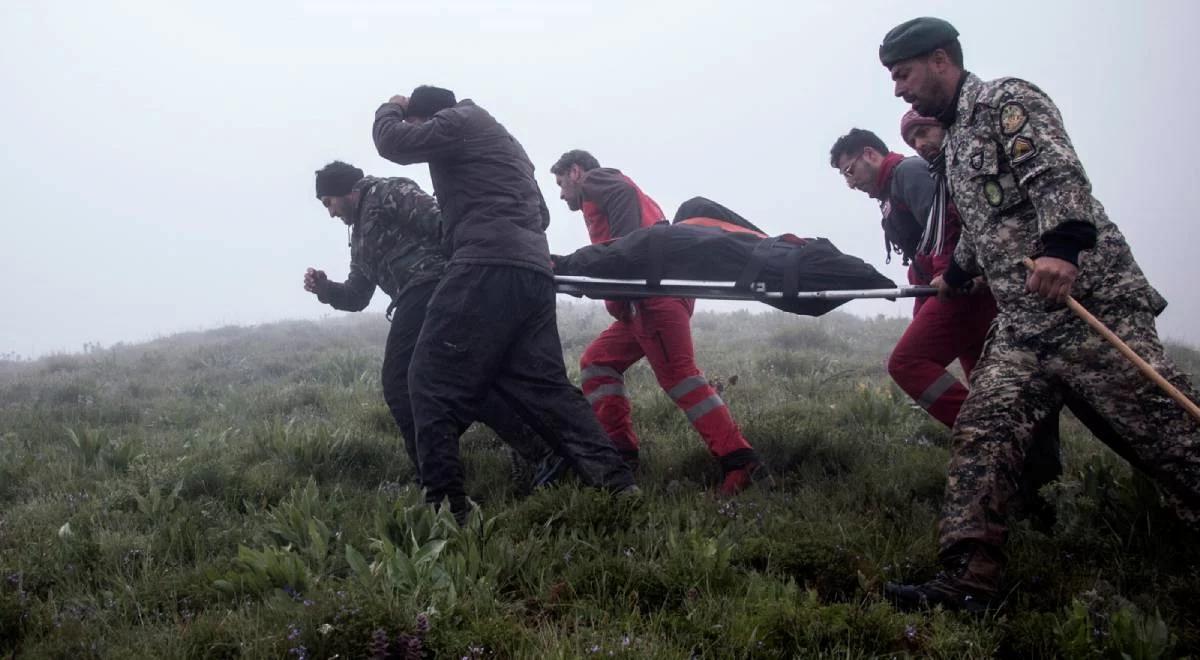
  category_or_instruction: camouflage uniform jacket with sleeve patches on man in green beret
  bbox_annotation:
[944,73,1166,338]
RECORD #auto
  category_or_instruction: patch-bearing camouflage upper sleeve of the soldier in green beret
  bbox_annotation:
[996,79,1096,235]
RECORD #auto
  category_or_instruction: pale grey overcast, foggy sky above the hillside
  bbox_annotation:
[0,0,1200,356]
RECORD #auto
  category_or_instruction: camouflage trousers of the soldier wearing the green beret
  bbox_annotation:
[938,304,1200,572]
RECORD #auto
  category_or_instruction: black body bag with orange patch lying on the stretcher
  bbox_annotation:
[554,198,896,317]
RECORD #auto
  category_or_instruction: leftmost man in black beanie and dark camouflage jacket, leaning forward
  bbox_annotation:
[304,161,563,496]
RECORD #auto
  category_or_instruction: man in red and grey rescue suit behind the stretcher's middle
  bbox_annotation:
[550,150,766,494]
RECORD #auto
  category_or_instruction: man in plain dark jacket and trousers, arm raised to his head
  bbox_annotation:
[372,86,636,518]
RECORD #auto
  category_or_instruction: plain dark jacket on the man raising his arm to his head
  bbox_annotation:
[372,100,551,275]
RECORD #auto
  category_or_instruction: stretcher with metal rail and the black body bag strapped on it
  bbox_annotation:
[554,198,936,316]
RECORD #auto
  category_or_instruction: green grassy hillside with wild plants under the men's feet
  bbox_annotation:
[0,306,1200,659]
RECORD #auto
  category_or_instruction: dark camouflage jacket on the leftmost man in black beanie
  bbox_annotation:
[317,176,446,312]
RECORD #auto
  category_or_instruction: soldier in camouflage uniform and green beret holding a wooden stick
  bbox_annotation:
[880,18,1200,610]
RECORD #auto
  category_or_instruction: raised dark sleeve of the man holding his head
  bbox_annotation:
[371,103,466,164]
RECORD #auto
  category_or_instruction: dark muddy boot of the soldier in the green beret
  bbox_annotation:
[883,545,1003,613]
